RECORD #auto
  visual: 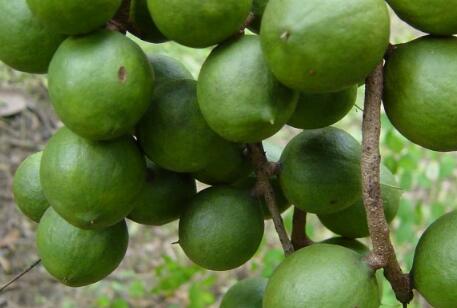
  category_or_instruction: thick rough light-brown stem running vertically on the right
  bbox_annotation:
[361,63,413,305]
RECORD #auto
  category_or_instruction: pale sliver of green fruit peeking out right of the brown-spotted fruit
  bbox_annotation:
[148,54,194,88]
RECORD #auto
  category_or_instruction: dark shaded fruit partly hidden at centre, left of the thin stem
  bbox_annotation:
[193,143,253,185]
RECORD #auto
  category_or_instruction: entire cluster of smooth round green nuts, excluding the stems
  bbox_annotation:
[0,0,457,308]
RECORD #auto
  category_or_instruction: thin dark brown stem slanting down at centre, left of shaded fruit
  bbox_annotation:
[248,143,294,256]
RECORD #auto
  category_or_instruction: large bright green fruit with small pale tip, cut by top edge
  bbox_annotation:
[260,0,390,92]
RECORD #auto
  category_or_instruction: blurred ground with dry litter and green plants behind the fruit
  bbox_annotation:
[0,10,448,308]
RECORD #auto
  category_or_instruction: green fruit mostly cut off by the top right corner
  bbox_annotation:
[387,0,457,35]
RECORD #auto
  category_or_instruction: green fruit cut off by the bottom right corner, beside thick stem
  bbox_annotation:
[411,211,457,308]
